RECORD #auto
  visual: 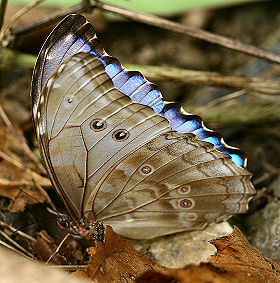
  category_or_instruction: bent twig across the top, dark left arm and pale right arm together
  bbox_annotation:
[8,1,280,63]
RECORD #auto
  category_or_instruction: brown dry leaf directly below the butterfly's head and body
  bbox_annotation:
[74,226,171,283]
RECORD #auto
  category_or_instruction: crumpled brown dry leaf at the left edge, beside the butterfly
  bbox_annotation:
[0,127,50,212]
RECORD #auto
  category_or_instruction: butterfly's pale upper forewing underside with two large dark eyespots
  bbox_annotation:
[37,53,170,218]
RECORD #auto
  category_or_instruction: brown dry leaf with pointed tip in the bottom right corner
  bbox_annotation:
[136,227,280,283]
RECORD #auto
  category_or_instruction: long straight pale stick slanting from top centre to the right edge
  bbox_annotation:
[94,1,280,63]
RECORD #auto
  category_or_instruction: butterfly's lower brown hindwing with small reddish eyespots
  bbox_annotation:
[84,131,254,239]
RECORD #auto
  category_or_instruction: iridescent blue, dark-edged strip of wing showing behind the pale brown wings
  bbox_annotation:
[32,15,246,167]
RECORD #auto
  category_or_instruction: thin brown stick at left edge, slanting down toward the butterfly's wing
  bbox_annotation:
[0,105,46,174]
